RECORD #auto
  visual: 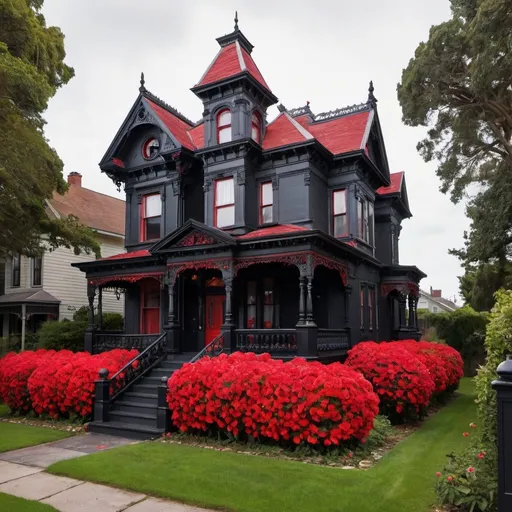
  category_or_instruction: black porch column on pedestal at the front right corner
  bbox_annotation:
[295,258,318,358]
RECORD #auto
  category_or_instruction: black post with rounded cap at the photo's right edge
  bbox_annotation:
[492,355,512,512]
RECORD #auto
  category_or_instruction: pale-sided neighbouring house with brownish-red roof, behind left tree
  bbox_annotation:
[0,172,125,344]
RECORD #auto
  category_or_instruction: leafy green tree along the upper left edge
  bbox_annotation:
[0,0,99,255]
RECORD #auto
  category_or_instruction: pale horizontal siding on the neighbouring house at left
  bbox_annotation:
[43,235,124,320]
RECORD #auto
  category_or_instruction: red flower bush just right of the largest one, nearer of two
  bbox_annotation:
[346,341,435,421]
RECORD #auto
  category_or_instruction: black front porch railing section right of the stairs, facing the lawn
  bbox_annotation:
[235,329,297,354]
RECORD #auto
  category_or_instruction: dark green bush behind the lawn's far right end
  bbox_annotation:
[433,306,489,375]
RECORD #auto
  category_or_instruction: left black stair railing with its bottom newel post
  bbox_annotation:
[93,333,167,421]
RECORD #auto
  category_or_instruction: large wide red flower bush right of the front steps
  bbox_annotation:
[167,352,378,446]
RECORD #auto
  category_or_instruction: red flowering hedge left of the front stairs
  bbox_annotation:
[0,349,138,419]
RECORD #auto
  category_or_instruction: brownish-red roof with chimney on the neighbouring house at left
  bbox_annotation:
[49,173,125,236]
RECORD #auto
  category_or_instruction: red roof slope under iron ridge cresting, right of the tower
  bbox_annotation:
[306,111,370,155]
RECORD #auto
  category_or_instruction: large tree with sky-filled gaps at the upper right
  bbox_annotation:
[398,0,512,202]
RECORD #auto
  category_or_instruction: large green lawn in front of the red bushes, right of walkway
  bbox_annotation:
[49,379,476,512]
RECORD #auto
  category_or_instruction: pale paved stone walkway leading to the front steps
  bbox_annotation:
[0,433,212,512]
